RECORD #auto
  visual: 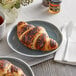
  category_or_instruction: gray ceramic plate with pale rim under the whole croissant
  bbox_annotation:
[7,21,62,57]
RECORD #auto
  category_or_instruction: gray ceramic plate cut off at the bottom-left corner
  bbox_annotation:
[0,57,34,76]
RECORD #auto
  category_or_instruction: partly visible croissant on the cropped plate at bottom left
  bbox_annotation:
[0,60,26,76]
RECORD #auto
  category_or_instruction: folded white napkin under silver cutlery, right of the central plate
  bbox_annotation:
[54,21,76,65]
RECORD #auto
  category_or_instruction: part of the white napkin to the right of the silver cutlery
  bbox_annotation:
[64,26,76,64]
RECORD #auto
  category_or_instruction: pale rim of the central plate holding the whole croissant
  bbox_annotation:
[7,20,63,57]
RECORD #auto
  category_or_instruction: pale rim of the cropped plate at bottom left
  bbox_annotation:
[0,56,35,76]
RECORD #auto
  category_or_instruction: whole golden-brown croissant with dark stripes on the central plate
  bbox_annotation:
[17,22,58,51]
